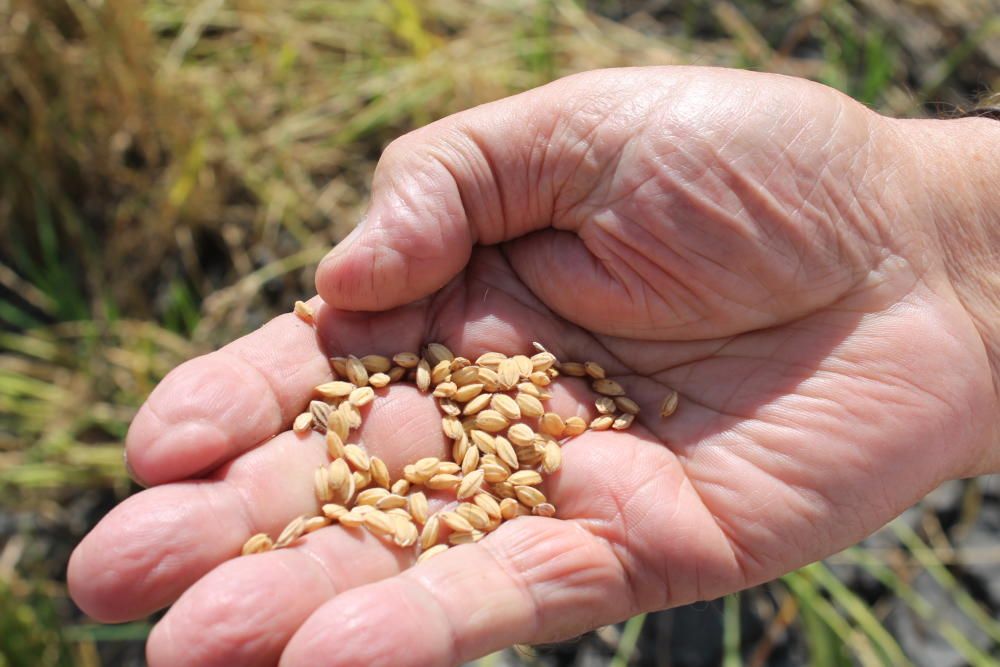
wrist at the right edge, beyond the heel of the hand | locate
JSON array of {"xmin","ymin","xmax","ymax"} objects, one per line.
[{"xmin": 902, "ymin": 118, "xmax": 1000, "ymax": 474}]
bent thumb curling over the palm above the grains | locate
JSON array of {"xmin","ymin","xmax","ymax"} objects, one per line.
[{"xmin": 316, "ymin": 73, "xmax": 592, "ymax": 311}]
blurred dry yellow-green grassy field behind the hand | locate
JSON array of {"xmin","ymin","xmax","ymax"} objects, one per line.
[{"xmin": 0, "ymin": 0, "xmax": 1000, "ymax": 667}]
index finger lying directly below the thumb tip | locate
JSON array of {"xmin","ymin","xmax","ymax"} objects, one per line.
[{"xmin": 125, "ymin": 306, "xmax": 330, "ymax": 485}]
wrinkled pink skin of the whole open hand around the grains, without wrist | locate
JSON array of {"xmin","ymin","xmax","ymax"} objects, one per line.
[{"xmin": 69, "ymin": 68, "xmax": 997, "ymax": 667}]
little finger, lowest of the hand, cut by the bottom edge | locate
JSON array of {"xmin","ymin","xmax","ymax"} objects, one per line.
[{"xmin": 281, "ymin": 517, "xmax": 633, "ymax": 667}]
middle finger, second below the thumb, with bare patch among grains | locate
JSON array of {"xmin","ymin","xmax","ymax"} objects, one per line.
[{"xmin": 68, "ymin": 387, "xmax": 445, "ymax": 622}]
